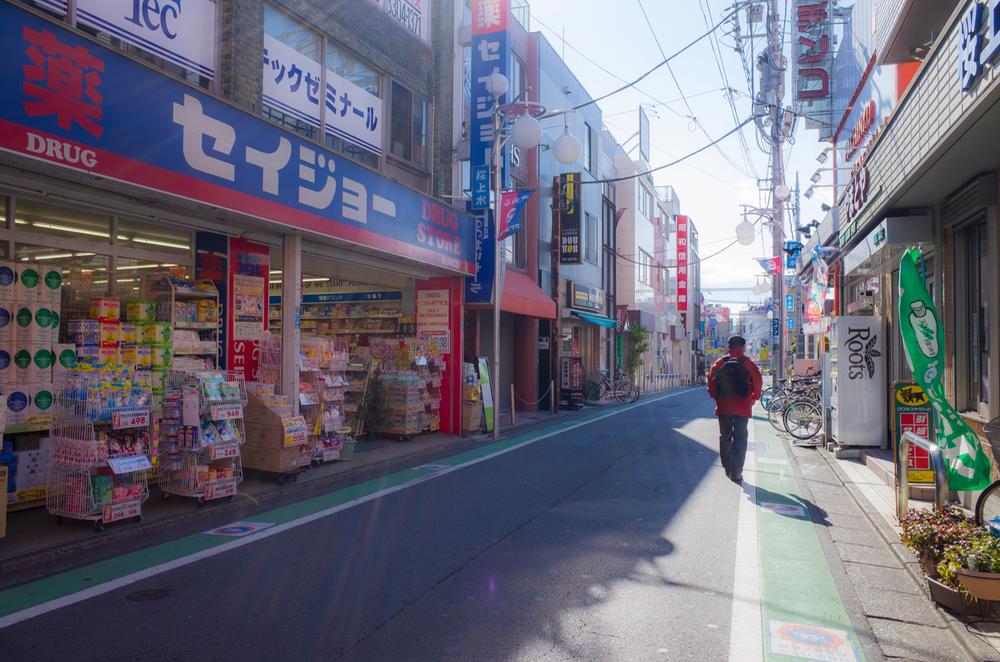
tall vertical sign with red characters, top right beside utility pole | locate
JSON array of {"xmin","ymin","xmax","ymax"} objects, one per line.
[{"xmin": 792, "ymin": 0, "xmax": 834, "ymax": 140}]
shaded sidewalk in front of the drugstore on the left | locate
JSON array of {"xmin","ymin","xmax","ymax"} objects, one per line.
[{"xmin": 0, "ymin": 393, "xmax": 648, "ymax": 588}]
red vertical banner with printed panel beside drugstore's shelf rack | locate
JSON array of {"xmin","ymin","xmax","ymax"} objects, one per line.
[{"xmin": 225, "ymin": 237, "xmax": 270, "ymax": 382}]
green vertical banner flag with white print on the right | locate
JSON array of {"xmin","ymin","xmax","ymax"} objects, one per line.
[{"xmin": 899, "ymin": 248, "xmax": 990, "ymax": 492}]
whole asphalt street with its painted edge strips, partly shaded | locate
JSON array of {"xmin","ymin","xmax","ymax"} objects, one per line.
[{"xmin": 0, "ymin": 389, "xmax": 984, "ymax": 662}]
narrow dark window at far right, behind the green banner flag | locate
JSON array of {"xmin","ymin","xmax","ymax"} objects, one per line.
[{"xmin": 956, "ymin": 221, "xmax": 992, "ymax": 415}]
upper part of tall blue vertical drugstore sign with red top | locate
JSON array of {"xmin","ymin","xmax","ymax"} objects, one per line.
[{"xmin": 469, "ymin": 0, "xmax": 510, "ymax": 172}]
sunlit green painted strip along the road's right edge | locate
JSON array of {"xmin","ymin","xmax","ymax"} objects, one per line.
[{"xmin": 752, "ymin": 422, "xmax": 865, "ymax": 662}]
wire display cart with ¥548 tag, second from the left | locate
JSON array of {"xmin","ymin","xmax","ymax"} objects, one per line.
[{"xmin": 159, "ymin": 370, "xmax": 247, "ymax": 506}]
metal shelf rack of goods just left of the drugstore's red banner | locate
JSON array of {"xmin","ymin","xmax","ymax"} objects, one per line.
[{"xmin": 140, "ymin": 274, "xmax": 219, "ymax": 372}]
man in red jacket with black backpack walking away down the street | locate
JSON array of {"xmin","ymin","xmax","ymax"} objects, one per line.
[{"xmin": 708, "ymin": 336, "xmax": 763, "ymax": 483}]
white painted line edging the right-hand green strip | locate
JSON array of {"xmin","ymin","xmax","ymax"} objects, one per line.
[{"xmin": 729, "ymin": 420, "xmax": 764, "ymax": 662}]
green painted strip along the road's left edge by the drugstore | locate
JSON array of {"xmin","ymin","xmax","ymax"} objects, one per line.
[{"xmin": 0, "ymin": 389, "xmax": 695, "ymax": 628}]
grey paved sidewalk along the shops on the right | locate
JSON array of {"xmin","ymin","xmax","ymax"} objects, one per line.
[{"xmin": 756, "ymin": 420, "xmax": 1000, "ymax": 662}]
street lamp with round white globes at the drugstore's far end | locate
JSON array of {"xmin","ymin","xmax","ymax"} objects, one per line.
[{"xmin": 486, "ymin": 71, "xmax": 581, "ymax": 439}]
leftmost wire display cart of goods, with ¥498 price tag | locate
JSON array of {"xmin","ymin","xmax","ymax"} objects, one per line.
[{"xmin": 46, "ymin": 368, "xmax": 153, "ymax": 531}]
